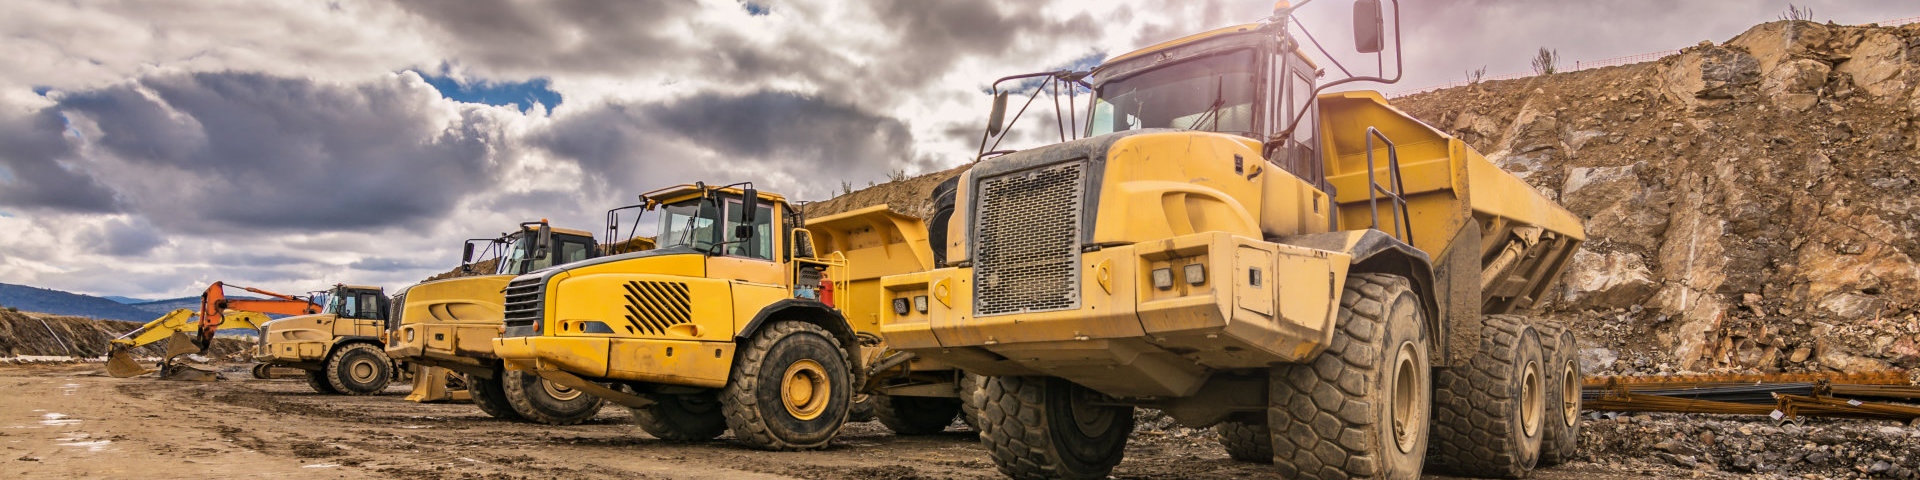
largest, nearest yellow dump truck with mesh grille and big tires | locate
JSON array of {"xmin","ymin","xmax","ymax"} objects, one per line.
[{"xmin": 879, "ymin": 0, "xmax": 1584, "ymax": 478}]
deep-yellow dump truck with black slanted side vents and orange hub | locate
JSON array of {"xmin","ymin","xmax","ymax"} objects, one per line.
[{"xmin": 493, "ymin": 184, "xmax": 958, "ymax": 449}]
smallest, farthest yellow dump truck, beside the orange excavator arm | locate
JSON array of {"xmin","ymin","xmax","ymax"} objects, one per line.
[{"xmin": 255, "ymin": 284, "xmax": 396, "ymax": 396}]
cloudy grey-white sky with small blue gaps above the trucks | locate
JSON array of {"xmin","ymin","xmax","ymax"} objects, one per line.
[{"xmin": 0, "ymin": 0, "xmax": 1920, "ymax": 298}]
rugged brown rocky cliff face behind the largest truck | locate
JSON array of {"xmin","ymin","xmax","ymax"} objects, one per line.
[{"xmin": 1394, "ymin": 21, "xmax": 1920, "ymax": 371}]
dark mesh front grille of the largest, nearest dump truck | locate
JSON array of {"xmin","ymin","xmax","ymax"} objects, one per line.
[{"xmin": 973, "ymin": 161, "xmax": 1087, "ymax": 317}]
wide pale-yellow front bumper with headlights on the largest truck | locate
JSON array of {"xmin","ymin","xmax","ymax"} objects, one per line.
[{"xmin": 879, "ymin": 232, "xmax": 1350, "ymax": 397}]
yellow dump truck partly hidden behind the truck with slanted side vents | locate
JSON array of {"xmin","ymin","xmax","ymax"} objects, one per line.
[{"xmin": 386, "ymin": 221, "xmax": 645, "ymax": 424}]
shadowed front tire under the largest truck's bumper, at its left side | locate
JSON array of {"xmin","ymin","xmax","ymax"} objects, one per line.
[{"xmin": 979, "ymin": 376, "xmax": 1133, "ymax": 480}]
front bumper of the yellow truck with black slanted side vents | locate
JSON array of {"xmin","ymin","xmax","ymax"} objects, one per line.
[{"xmin": 493, "ymin": 336, "xmax": 733, "ymax": 388}]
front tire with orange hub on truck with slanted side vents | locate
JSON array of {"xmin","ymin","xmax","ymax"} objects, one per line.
[{"xmin": 720, "ymin": 321, "xmax": 848, "ymax": 449}]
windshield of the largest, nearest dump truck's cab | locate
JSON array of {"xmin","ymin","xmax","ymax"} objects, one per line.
[{"xmin": 1087, "ymin": 50, "xmax": 1258, "ymax": 136}]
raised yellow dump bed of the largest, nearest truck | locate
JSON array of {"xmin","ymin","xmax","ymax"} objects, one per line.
[{"xmin": 1319, "ymin": 92, "xmax": 1586, "ymax": 313}]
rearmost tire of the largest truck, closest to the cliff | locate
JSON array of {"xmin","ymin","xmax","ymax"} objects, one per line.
[{"xmin": 1534, "ymin": 323, "xmax": 1586, "ymax": 467}]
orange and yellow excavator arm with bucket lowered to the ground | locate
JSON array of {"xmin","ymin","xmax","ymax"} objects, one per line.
[{"xmin": 108, "ymin": 282, "xmax": 321, "ymax": 382}]
